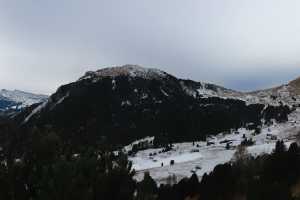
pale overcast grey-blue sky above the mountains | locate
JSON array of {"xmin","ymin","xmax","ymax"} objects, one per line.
[{"xmin": 0, "ymin": 0, "xmax": 300, "ymax": 93}]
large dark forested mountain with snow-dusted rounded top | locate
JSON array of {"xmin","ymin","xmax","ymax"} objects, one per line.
[{"xmin": 16, "ymin": 65, "xmax": 291, "ymax": 146}]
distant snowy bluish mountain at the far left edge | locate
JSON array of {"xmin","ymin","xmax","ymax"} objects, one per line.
[{"xmin": 0, "ymin": 89, "xmax": 48, "ymax": 114}]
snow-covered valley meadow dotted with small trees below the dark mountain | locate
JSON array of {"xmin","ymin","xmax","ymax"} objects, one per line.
[{"xmin": 129, "ymin": 110, "xmax": 300, "ymax": 183}]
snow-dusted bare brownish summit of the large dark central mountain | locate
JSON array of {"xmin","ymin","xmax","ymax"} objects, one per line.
[{"xmin": 79, "ymin": 65, "xmax": 167, "ymax": 80}]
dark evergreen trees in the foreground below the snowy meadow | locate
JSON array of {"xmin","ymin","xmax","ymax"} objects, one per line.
[{"xmin": 0, "ymin": 119, "xmax": 300, "ymax": 200}]
